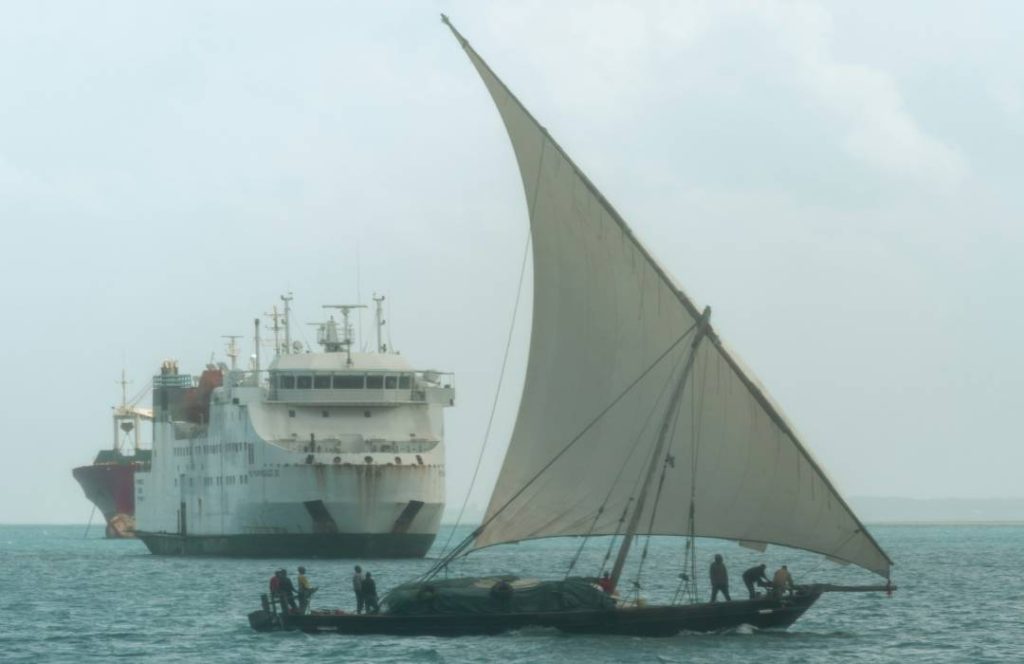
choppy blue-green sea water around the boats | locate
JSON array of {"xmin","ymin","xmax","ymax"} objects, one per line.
[{"xmin": 0, "ymin": 526, "xmax": 1024, "ymax": 664}]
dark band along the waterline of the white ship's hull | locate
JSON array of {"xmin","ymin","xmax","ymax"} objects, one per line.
[{"xmin": 136, "ymin": 532, "xmax": 435, "ymax": 558}]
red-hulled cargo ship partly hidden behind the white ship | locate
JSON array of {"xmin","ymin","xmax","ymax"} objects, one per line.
[{"xmin": 72, "ymin": 372, "xmax": 153, "ymax": 539}]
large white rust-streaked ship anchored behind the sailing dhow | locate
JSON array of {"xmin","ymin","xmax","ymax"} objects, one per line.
[{"xmin": 135, "ymin": 298, "xmax": 455, "ymax": 557}]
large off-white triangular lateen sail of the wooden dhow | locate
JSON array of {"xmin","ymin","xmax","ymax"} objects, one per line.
[{"xmin": 453, "ymin": 18, "xmax": 891, "ymax": 577}]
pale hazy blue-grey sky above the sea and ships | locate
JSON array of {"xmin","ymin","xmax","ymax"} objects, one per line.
[{"xmin": 0, "ymin": 1, "xmax": 1024, "ymax": 523}]
